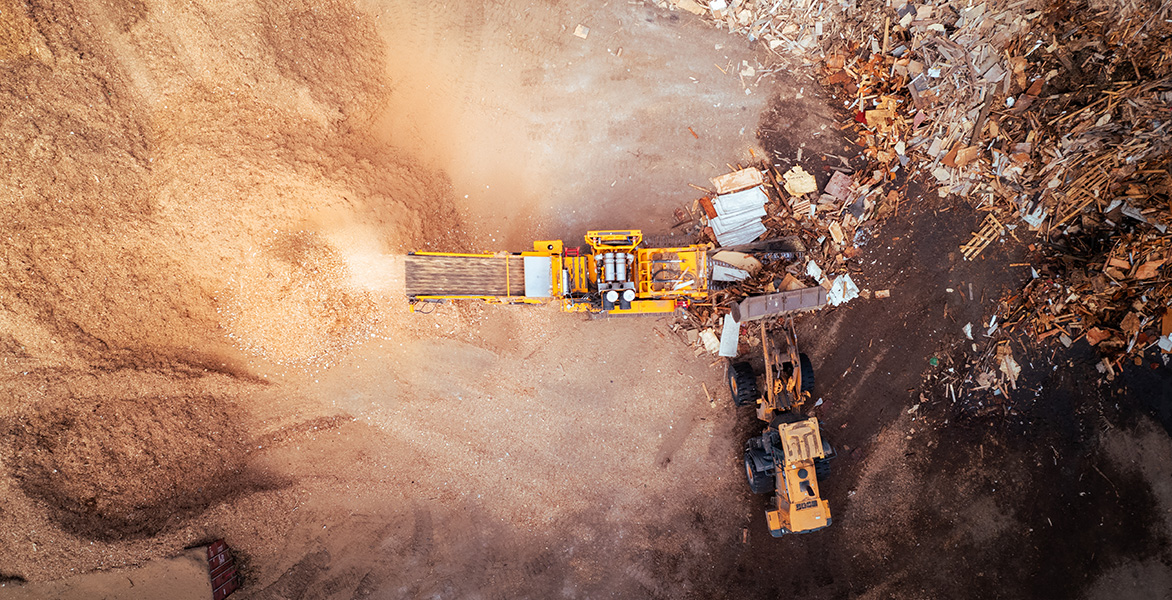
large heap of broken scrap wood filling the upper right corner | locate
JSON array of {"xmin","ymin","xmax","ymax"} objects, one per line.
[{"xmin": 663, "ymin": 0, "xmax": 1172, "ymax": 364}]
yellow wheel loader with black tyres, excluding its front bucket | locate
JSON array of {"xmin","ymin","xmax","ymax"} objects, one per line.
[{"xmin": 728, "ymin": 320, "xmax": 834, "ymax": 537}]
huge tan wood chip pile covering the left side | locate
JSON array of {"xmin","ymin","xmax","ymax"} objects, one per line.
[{"xmin": 0, "ymin": 0, "xmax": 461, "ymax": 579}]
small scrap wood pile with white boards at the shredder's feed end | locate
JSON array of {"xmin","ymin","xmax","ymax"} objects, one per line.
[{"xmin": 686, "ymin": 164, "xmax": 890, "ymax": 353}]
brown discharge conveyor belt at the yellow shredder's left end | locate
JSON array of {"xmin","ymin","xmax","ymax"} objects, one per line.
[{"xmin": 407, "ymin": 254, "xmax": 525, "ymax": 296}]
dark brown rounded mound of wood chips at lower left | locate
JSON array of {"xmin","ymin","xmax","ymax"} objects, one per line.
[{"xmin": 9, "ymin": 396, "xmax": 263, "ymax": 540}]
